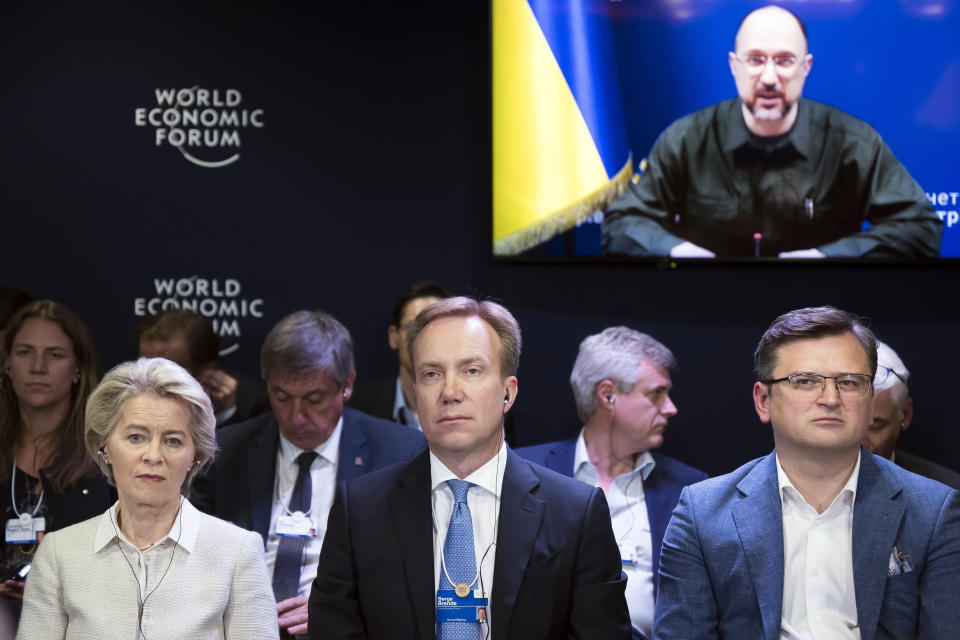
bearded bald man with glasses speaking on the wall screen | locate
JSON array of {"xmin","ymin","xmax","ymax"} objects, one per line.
[{"xmin": 603, "ymin": 6, "xmax": 942, "ymax": 258}]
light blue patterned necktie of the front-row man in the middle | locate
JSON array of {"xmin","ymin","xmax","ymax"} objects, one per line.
[{"xmin": 437, "ymin": 480, "xmax": 480, "ymax": 640}]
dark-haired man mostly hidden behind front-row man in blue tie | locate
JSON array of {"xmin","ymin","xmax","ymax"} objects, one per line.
[{"xmin": 349, "ymin": 280, "xmax": 450, "ymax": 431}]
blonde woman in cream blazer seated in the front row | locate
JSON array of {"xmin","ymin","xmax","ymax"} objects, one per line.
[{"xmin": 17, "ymin": 358, "xmax": 278, "ymax": 640}]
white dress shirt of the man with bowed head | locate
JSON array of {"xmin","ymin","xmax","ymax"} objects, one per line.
[{"xmin": 266, "ymin": 417, "xmax": 343, "ymax": 597}]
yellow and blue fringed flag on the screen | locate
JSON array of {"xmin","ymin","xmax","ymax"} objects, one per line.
[{"xmin": 493, "ymin": 0, "xmax": 631, "ymax": 255}]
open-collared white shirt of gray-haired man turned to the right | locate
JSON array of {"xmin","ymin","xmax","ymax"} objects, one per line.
[{"xmin": 573, "ymin": 429, "xmax": 656, "ymax": 638}]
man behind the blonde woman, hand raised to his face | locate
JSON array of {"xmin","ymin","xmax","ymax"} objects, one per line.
[{"xmin": 137, "ymin": 309, "xmax": 270, "ymax": 427}]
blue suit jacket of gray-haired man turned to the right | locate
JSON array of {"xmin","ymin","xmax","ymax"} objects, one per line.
[{"xmin": 517, "ymin": 438, "xmax": 707, "ymax": 594}]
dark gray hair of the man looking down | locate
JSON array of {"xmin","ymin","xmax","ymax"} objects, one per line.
[{"xmin": 260, "ymin": 311, "xmax": 354, "ymax": 387}]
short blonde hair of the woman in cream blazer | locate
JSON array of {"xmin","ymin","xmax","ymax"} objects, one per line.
[{"xmin": 83, "ymin": 358, "xmax": 217, "ymax": 493}]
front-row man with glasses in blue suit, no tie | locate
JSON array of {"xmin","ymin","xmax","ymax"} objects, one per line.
[{"xmin": 654, "ymin": 307, "xmax": 960, "ymax": 640}]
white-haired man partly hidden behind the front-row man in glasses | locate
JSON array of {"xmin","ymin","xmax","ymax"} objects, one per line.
[{"xmin": 863, "ymin": 340, "xmax": 960, "ymax": 489}]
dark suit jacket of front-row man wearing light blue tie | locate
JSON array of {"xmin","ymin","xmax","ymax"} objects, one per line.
[{"xmin": 309, "ymin": 451, "xmax": 630, "ymax": 640}]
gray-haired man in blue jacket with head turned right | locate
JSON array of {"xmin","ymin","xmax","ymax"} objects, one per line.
[{"xmin": 517, "ymin": 327, "xmax": 707, "ymax": 638}]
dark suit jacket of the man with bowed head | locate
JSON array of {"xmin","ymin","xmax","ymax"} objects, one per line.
[{"xmin": 190, "ymin": 409, "xmax": 427, "ymax": 543}]
